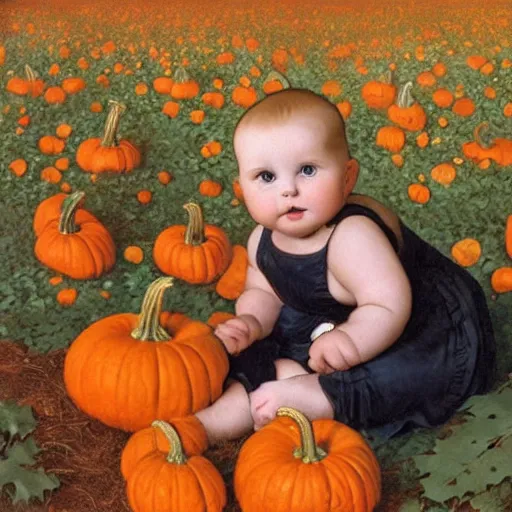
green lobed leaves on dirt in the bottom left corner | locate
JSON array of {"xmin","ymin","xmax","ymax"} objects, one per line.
[{"xmin": 0, "ymin": 401, "xmax": 60, "ymax": 504}]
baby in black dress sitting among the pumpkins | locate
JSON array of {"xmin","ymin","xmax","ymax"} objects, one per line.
[{"xmin": 196, "ymin": 89, "xmax": 495, "ymax": 443}]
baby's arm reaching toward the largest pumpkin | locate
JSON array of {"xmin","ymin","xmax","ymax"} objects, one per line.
[{"xmin": 215, "ymin": 226, "xmax": 283, "ymax": 355}]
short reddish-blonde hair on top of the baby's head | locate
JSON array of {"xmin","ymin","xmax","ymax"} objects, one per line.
[{"xmin": 233, "ymin": 88, "xmax": 350, "ymax": 158}]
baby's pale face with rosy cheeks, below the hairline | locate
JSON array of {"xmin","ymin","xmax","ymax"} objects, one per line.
[{"xmin": 234, "ymin": 117, "xmax": 350, "ymax": 238}]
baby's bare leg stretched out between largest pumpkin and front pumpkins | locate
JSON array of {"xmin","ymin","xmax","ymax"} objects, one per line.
[{"xmin": 196, "ymin": 381, "xmax": 253, "ymax": 444}]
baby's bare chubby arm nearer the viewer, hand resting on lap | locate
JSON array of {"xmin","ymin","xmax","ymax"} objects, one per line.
[{"xmin": 308, "ymin": 216, "xmax": 412, "ymax": 374}]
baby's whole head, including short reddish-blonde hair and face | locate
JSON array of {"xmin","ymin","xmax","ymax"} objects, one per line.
[{"xmin": 233, "ymin": 89, "xmax": 357, "ymax": 237}]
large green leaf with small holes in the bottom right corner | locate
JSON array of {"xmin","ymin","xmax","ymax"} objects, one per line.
[{"xmin": 413, "ymin": 382, "xmax": 512, "ymax": 503}]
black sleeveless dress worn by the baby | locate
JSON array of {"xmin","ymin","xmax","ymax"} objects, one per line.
[{"xmin": 230, "ymin": 204, "xmax": 496, "ymax": 437}]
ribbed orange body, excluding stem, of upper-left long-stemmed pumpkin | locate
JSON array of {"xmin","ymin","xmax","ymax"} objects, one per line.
[{"xmin": 76, "ymin": 137, "xmax": 140, "ymax": 173}]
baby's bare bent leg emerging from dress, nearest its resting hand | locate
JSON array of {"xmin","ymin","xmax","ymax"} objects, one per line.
[{"xmin": 249, "ymin": 359, "xmax": 334, "ymax": 430}]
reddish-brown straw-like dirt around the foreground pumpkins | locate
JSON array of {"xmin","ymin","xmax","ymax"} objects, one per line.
[{"xmin": 0, "ymin": 341, "xmax": 472, "ymax": 512}]
